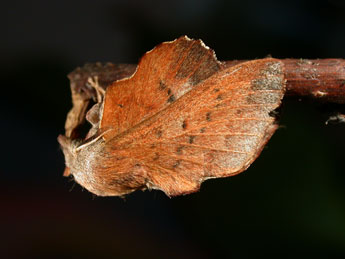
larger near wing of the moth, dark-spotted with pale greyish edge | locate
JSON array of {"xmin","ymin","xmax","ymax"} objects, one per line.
[{"xmin": 108, "ymin": 58, "xmax": 285, "ymax": 196}]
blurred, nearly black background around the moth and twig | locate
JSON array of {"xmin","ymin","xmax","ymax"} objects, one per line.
[{"xmin": 0, "ymin": 0, "xmax": 345, "ymax": 258}]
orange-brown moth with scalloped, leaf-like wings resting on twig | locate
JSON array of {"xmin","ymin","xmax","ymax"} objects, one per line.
[{"xmin": 58, "ymin": 37, "xmax": 285, "ymax": 196}]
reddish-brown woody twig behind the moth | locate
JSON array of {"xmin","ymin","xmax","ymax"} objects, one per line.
[{"xmin": 68, "ymin": 59, "xmax": 345, "ymax": 103}]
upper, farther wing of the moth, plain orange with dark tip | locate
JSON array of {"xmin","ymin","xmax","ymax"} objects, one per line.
[{"xmin": 101, "ymin": 37, "xmax": 221, "ymax": 138}]
